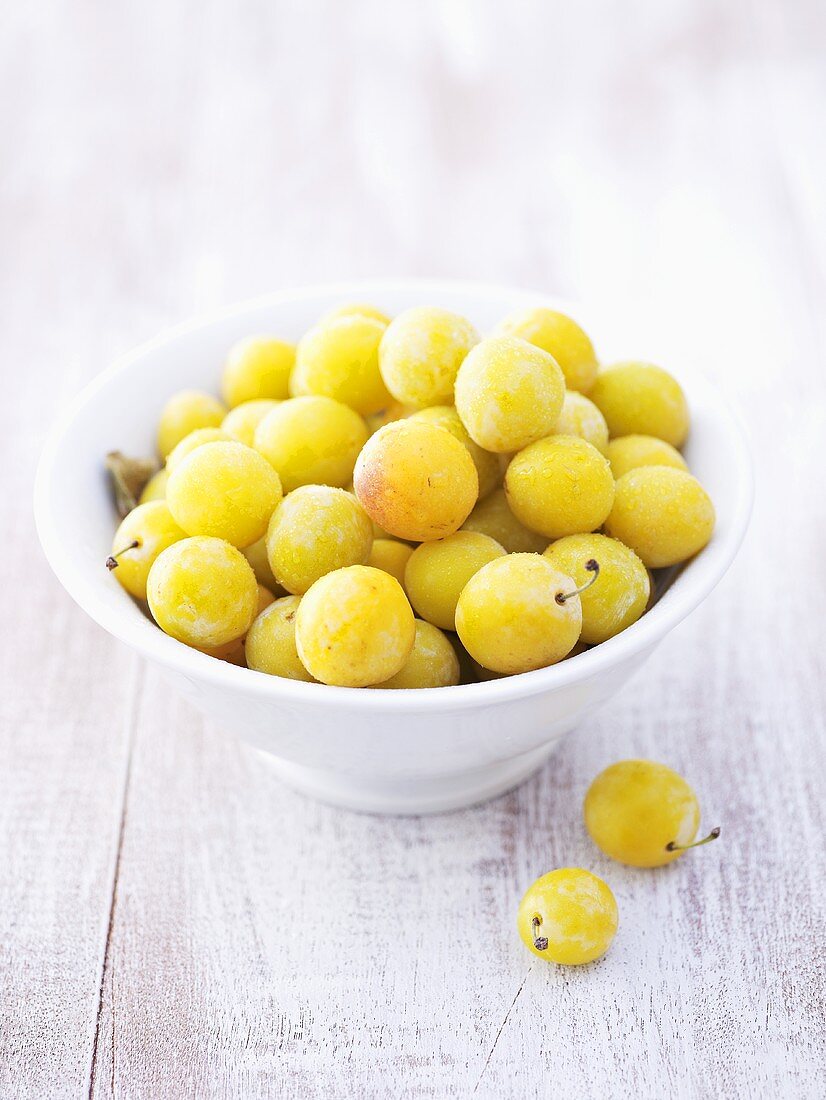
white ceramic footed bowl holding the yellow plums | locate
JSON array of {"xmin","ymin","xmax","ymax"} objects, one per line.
[{"xmin": 35, "ymin": 281, "xmax": 752, "ymax": 813}]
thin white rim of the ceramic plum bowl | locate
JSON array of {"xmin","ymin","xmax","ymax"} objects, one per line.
[{"xmin": 34, "ymin": 278, "xmax": 753, "ymax": 713}]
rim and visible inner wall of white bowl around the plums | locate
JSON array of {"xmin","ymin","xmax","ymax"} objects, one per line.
[{"xmin": 35, "ymin": 281, "xmax": 751, "ymax": 706}]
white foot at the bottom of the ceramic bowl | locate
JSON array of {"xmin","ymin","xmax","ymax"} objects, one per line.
[{"xmin": 258, "ymin": 740, "xmax": 559, "ymax": 815}]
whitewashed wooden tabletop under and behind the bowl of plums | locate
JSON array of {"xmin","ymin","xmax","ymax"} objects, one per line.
[{"xmin": 0, "ymin": 0, "xmax": 826, "ymax": 1100}]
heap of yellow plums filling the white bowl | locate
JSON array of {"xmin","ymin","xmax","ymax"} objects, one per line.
[{"xmin": 107, "ymin": 305, "xmax": 714, "ymax": 688}]
